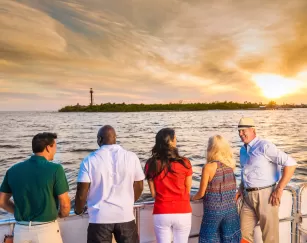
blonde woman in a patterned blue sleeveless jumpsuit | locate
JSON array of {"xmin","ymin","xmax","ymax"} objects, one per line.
[{"xmin": 192, "ymin": 135, "xmax": 241, "ymax": 243}]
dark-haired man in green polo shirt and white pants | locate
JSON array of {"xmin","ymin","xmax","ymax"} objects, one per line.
[{"xmin": 0, "ymin": 133, "xmax": 70, "ymax": 243}]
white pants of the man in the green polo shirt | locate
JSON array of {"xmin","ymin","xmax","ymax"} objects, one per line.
[{"xmin": 14, "ymin": 221, "xmax": 63, "ymax": 243}]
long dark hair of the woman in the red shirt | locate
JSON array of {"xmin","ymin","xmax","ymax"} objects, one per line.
[{"xmin": 145, "ymin": 128, "xmax": 190, "ymax": 180}]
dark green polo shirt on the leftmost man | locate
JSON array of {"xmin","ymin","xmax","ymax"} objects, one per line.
[{"xmin": 0, "ymin": 155, "xmax": 69, "ymax": 222}]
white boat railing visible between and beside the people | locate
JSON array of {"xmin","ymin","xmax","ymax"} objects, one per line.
[{"xmin": 0, "ymin": 183, "xmax": 307, "ymax": 243}]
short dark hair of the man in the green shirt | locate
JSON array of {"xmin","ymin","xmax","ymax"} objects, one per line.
[{"xmin": 32, "ymin": 132, "xmax": 58, "ymax": 153}]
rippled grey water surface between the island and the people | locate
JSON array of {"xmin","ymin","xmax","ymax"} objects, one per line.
[{"xmin": 0, "ymin": 109, "xmax": 307, "ymax": 215}]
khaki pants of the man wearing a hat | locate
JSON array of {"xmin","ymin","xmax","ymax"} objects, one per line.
[{"xmin": 240, "ymin": 187, "xmax": 279, "ymax": 243}]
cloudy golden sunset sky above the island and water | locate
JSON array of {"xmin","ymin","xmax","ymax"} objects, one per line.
[{"xmin": 0, "ymin": 0, "xmax": 307, "ymax": 110}]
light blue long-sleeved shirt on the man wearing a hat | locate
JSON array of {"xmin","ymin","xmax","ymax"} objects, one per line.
[{"xmin": 240, "ymin": 137, "xmax": 296, "ymax": 188}]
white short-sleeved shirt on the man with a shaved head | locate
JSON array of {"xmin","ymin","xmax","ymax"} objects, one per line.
[{"xmin": 78, "ymin": 144, "xmax": 145, "ymax": 224}]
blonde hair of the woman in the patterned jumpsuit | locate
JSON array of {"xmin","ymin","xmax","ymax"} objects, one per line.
[{"xmin": 207, "ymin": 135, "xmax": 236, "ymax": 169}]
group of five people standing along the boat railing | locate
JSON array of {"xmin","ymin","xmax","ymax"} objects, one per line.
[{"xmin": 0, "ymin": 117, "xmax": 296, "ymax": 243}]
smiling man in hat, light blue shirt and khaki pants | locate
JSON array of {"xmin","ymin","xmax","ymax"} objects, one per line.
[{"xmin": 237, "ymin": 117, "xmax": 296, "ymax": 243}]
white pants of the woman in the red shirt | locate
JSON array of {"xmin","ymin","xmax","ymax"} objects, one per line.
[{"xmin": 153, "ymin": 213, "xmax": 192, "ymax": 243}]
